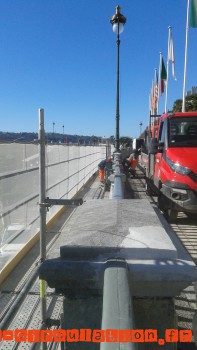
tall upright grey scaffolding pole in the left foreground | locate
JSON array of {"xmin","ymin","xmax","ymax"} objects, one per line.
[{"xmin": 38, "ymin": 108, "xmax": 47, "ymax": 350}]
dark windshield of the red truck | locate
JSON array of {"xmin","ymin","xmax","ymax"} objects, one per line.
[{"xmin": 168, "ymin": 117, "xmax": 197, "ymax": 147}]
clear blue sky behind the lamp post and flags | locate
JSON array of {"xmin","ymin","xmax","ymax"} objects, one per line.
[{"xmin": 0, "ymin": 0, "xmax": 197, "ymax": 137}]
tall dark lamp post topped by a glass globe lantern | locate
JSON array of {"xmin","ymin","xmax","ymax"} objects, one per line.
[{"xmin": 110, "ymin": 6, "xmax": 126, "ymax": 152}]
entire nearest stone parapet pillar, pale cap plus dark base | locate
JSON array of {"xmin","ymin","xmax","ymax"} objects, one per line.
[{"xmin": 39, "ymin": 199, "xmax": 197, "ymax": 350}]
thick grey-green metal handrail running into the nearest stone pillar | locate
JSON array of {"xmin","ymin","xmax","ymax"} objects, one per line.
[{"xmin": 100, "ymin": 259, "xmax": 136, "ymax": 350}]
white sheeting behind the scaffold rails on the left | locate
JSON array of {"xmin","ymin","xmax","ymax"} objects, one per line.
[{"xmin": 0, "ymin": 143, "xmax": 106, "ymax": 259}]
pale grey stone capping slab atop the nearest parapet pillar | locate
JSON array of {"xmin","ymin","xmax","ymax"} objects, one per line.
[{"xmin": 40, "ymin": 200, "xmax": 197, "ymax": 297}]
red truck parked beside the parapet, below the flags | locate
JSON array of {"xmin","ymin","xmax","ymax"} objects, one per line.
[{"xmin": 139, "ymin": 112, "xmax": 197, "ymax": 221}]
